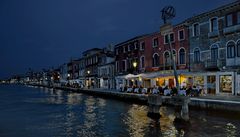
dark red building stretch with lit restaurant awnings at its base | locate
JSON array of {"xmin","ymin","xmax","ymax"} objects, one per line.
[{"xmin": 115, "ymin": 23, "xmax": 189, "ymax": 88}]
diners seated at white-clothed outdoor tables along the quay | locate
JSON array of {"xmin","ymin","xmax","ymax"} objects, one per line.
[{"xmin": 120, "ymin": 85, "xmax": 203, "ymax": 96}]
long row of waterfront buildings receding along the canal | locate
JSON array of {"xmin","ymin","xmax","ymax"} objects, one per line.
[{"xmin": 21, "ymin": 1, "xmax": 240, "ymax": 95}]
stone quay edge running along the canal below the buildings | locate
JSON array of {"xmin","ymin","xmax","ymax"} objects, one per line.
[{"xmin": 28, "ymin": 85, "xmax": 240, "ymax": 113}]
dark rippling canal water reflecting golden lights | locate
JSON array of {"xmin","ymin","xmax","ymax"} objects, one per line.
[{"xmin": 0, "ymin": 85, "xmax": 240, "ymax": 137}]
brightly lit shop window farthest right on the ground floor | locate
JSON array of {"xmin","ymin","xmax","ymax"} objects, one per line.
[{"xmin": 219, "ymin": 75, "xmax": 232, "ymax": 93}]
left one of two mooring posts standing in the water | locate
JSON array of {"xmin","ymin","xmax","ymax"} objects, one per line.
[{"xmin": 147, "ymin": 94, "xmax": 162, "ymax": 120}]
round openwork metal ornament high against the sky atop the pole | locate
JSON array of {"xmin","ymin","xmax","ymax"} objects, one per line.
[{"xmin": 161, "ymin": 6, "xmax": 176, "ymax": 24}]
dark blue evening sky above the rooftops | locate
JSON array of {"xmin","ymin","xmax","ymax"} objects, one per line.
[{"xmin": 0, "ymin": 0, "xmax": 234, "ymax": 78}]
